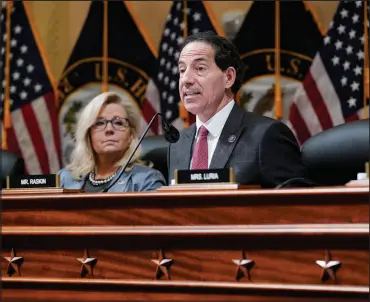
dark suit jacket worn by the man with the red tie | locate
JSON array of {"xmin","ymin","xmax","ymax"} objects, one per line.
[{"xmin": 167, "ymin": 104, "xmax": 306, "ymax": 188}]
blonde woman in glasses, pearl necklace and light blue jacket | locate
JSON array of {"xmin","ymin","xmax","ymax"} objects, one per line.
[{"xmin": 60, "ymin": 92, "xmax": 165, "ymax": 192}]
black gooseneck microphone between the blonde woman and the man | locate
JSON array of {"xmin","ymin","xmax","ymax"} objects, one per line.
[{"xmin": 103, "ymin": 112, "xmax": 180, "ymax": 192}]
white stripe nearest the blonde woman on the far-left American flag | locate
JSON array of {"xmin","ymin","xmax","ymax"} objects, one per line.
[{"xmin": 31, "ymin": 97, "xmax": 60, "ymax": 173}]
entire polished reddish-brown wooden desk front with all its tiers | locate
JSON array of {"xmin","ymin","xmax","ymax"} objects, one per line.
[{"xmin": 2, "ymin": 188, "xmax": 369, "ymax": 301}]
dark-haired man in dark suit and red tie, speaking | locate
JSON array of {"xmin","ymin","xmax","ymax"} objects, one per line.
[{"xmin": 168, "ymin": 32, "xmax": 306, "ymax": 188}]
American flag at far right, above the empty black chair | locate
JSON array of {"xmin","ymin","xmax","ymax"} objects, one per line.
[{"xmin": 288, "ymin": 1, "xmax": 369, "ymax": 144}]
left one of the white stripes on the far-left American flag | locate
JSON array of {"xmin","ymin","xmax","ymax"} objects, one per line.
[{"xmin": 12, "ymin": 109, "xmax": 42, "ymax": 174}]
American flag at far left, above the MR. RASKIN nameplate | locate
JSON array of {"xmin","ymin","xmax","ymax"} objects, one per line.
[{"xmin": 0, "ymin": 1, "xmax": 60, "ymax": 174}]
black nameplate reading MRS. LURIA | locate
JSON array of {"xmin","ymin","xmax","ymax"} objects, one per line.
[{"xmin": 175, "ymin": 168, "xmax": 235, "ymax": 184}]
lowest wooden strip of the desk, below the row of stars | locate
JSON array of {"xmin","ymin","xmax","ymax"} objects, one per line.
[{"xmin": 3, "ymin": 279, "xmax": 369, "ymax": 302}]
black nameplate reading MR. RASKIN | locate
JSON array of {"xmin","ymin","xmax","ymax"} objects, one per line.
[{"xmin": 6, "ymin": 174, "xmax": 60, "ymax": 189}]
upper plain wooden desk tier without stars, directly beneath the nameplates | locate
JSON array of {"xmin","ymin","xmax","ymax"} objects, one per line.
[{"xmin": 2, "ymin": 188, "xmax": 369, "ymax": 226}]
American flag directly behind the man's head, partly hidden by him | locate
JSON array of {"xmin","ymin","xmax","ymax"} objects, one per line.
[{"xmin": 156, "ymin": 1, "xmax": 223, "ymax": 128}]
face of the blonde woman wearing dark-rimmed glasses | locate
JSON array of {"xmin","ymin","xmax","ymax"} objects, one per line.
[{"xmin": 90, "ymin": 104, "xmax": 133, "ymax": 158}]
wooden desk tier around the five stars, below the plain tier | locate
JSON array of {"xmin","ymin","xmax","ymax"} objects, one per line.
[{"xmin": 2, "ymin": 224, "xmax": 369, "ymax": 296}]
